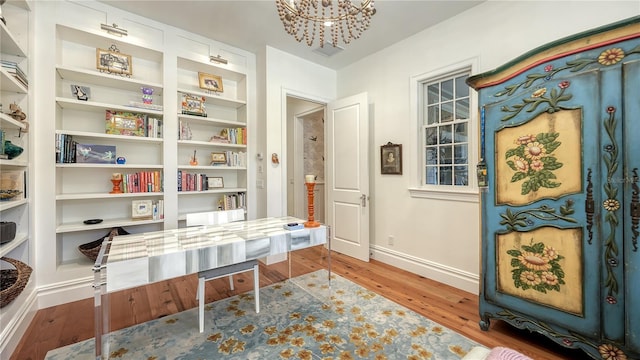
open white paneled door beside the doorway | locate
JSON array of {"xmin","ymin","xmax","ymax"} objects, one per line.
[{"xmin": 325, "ymin": 93, "xmax": 369, "ymax": 261}]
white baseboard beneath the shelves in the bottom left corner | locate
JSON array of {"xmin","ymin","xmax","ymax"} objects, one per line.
[{"xmin": 0, "ymin": 289, "xmax": 38, "ymax": 359}]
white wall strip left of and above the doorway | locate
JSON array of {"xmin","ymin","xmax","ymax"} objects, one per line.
[{"xmin": 259, "ymin": 46, "xmax": 336, "ymax": 216}]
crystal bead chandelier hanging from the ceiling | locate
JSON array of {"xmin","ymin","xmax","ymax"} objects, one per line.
[{"xmin": 276, "ymin": 0, "xmax": 376, "ymax": 47}]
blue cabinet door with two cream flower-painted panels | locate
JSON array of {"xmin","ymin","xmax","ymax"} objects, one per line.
[{"xmin": 481, "ymin": 70, "xmax": 601, "ymax": 336}]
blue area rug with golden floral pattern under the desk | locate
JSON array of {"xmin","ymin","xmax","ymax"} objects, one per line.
[{"xmin": 46, "ymin": 270, "xmax": 481, "ymax": 360}]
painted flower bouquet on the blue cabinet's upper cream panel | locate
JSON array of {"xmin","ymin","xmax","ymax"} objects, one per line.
[{"xmin": 505, "ymin": 132, "xmax": 562, "ymax": 195}]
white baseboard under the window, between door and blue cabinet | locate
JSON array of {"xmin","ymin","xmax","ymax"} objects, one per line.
[{"xmin": 370, "ymin": 246, "xmax": 480, "ymax": 295}]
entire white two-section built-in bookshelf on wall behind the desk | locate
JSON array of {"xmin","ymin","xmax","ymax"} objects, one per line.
[{"xmin": 29, "ymin": 1, "xmax": 255, "ymax": 320}]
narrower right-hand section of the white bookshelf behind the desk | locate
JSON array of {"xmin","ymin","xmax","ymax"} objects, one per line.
[{"xmin": 176, "ymin": 57, "xmax": 249, "ymax": 220}]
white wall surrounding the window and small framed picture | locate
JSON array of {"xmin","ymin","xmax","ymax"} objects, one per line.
[{"xmin": 338, "ymin": 1, "xmax": 640, "ymax": 293}]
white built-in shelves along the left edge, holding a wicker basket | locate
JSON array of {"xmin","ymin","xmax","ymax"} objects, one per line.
[{"xmin": 0, "ymin": 0, "xmax": 33, "ymax": 359}]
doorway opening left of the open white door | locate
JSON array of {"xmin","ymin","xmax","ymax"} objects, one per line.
[{"xmin": 286, "ymin": 96, "xmax": 326, "ymax": 223}]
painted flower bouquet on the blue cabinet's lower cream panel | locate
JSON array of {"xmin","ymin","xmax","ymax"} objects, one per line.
[{"xmin": 507, "ymin": 242, "xmax": 565, "ymax": 294}]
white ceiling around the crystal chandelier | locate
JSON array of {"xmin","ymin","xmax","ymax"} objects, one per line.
[{"xmin": 101, "ymin": 0, "xmax": 485, "ymax": 70}]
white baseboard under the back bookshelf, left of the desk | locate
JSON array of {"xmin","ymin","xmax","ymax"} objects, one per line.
[{"xmin": 38, "ymin": 276, "xmax": 94, "ymax": 309}]
